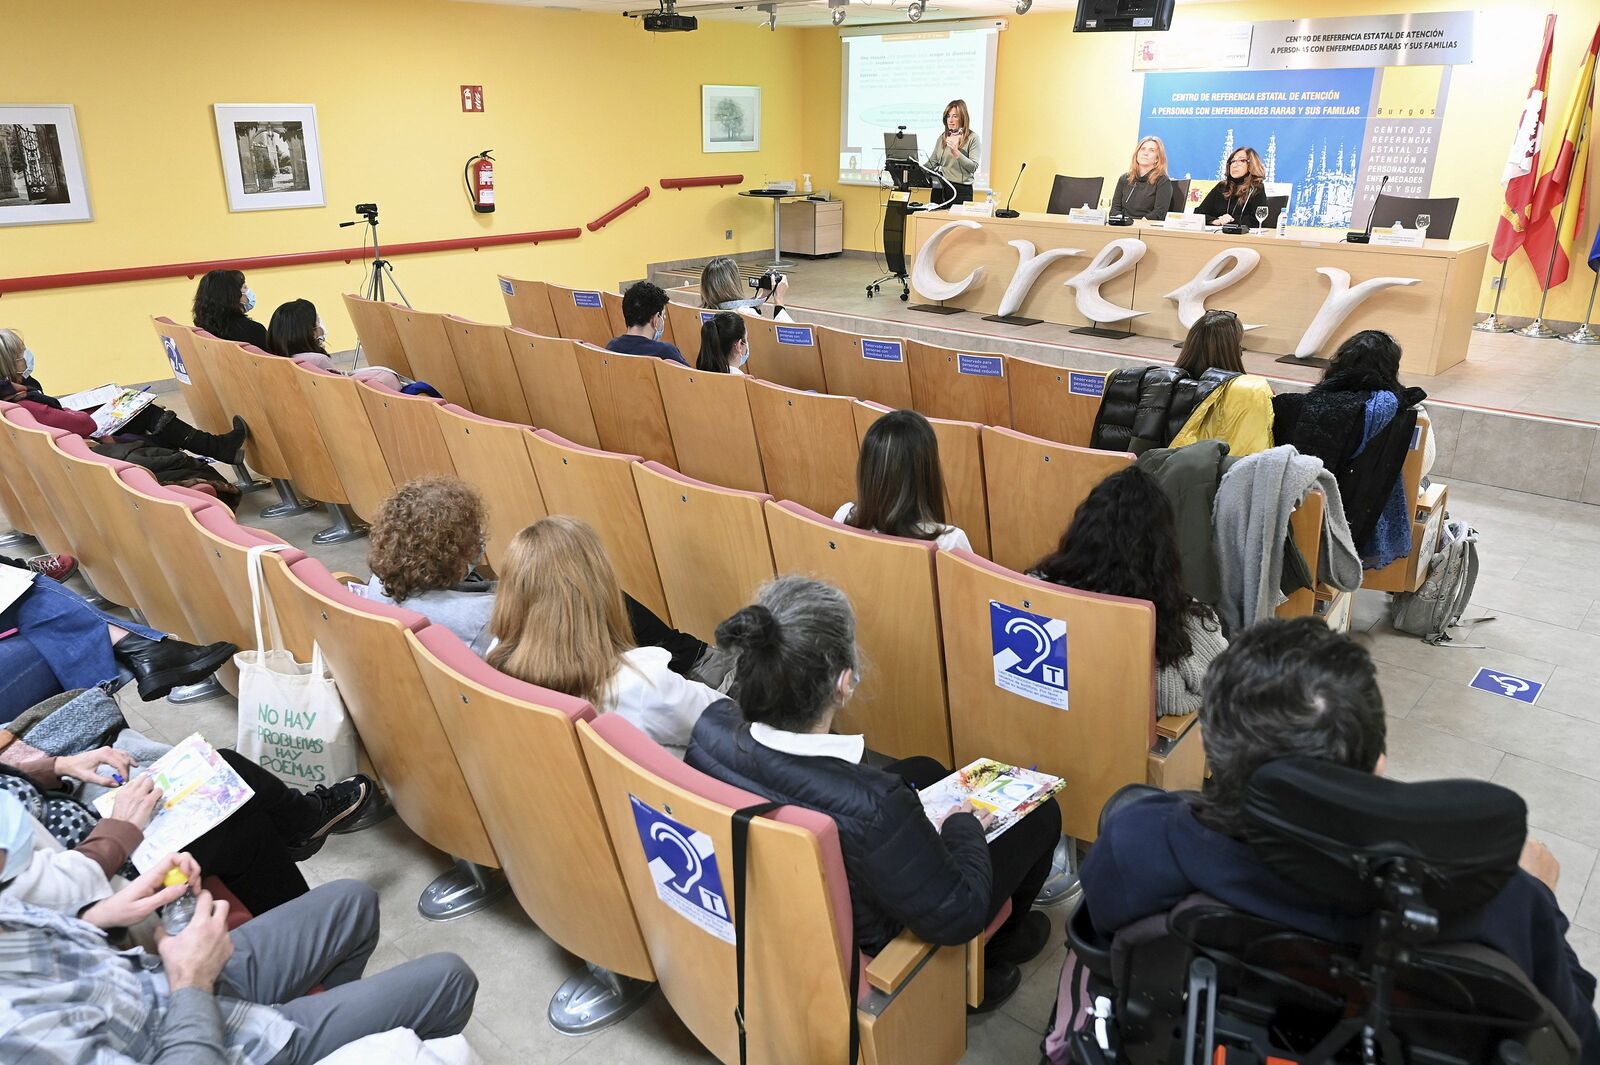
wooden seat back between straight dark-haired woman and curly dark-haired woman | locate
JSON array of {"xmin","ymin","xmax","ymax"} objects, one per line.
[{"xmin": 982, "ymin": 425, "xmax": 1133, "ymax": 572}]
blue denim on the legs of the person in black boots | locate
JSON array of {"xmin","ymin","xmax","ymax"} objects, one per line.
[{"xmin": 0, "ymin": 576, "xmax": 166, "ymax": 723}]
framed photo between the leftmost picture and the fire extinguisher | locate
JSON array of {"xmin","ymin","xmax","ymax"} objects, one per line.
[{"xmin": 213, "ymin": 104, "xmax": 323, "ymax": 211}]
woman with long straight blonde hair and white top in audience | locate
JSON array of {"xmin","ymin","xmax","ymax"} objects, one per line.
[{"xmin": 488, "ymin": 517, "xmax": 722, "ymax": 758}]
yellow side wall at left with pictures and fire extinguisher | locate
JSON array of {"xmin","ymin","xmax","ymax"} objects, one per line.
[{"xmin": 0, "ymin": 0, "xmax": 805, "ymax": 393}]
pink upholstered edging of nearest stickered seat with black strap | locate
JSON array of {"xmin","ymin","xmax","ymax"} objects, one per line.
[{"xmin": 594, "ymin": 713, "xmax": 866, "ymax": 998}]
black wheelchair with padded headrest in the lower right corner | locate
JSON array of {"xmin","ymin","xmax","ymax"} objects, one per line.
[{"xmin": 1067, "ymin": 758, "xmax": 1579, "ymax": 1065}]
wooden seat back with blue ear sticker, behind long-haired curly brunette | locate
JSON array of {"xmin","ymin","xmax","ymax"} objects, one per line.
[{"xmin": 938, "ymin": 552, "xmax": 1155, "ymax": 840}]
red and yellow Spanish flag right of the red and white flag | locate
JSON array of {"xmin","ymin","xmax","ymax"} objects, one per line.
[{"xmin": 1523, "ymin": 26, "xmax": 1600, "ymax": 289}]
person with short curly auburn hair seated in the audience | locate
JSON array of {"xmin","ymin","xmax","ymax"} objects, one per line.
[{"xmin": 366, "ymin": 477, "xmax": 494, "ymax": 656}]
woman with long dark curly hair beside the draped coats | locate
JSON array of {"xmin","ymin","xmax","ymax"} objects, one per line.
[{"xmin": 1029, "ymin": 467, "xmax": 1227, "ymax": 716}]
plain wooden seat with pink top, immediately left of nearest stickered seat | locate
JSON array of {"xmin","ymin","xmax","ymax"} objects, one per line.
[{"xmin": 406, "ymin": 625, "xmax": 656, "ymax": 1035}]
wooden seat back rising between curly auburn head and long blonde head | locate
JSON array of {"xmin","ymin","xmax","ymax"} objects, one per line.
[{"xmin": 434, "ymin": 403, "xmax": 547, "ymax": 569}]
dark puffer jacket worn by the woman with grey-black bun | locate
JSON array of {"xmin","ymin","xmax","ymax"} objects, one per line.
[{"xmin": 688, "ymin": 699, "xmax": 994, "ymax": 955}]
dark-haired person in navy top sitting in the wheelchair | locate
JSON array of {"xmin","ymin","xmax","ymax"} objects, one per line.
[{"xmin": 1082, "ymin": 617, "xmax": 1600, "ymax": 1065}]
